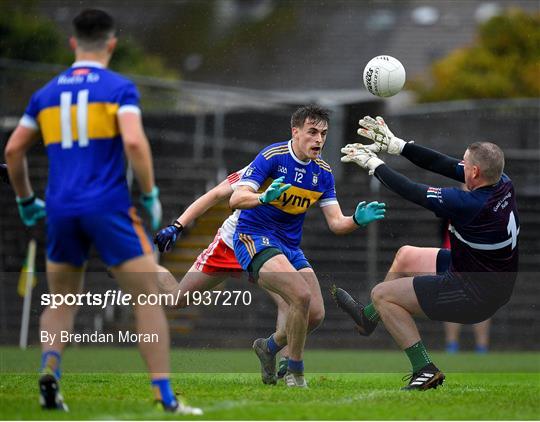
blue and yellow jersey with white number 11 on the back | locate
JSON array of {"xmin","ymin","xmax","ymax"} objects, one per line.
[{"xmin": 20, "ymin": 61, "xmax": 140, "ymax": 215}]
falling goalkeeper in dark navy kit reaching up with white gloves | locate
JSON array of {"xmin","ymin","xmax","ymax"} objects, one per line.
[{"xmin": 334, "ymin": 116, "xmax": 519, "ymax": 390}]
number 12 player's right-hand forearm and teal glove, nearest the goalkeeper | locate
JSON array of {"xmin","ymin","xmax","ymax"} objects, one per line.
[{"xmin": 322, "ymin": 201, "xmax": 386, "ymax": 235}]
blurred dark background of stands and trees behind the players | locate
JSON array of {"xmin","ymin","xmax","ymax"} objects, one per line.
[{"xmin": 0, "ymin": 0, "xmax": 540, "ymax": 350}]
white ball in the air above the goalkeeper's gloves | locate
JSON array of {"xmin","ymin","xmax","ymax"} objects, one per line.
[{"xmin": 364, "ymin": 56, "xmax": 405, "ymax": 97}]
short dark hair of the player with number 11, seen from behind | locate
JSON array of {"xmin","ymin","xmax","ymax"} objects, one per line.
[{"xmin": 73, "ymin": 9, "xmax": 115, "ymax": 50}]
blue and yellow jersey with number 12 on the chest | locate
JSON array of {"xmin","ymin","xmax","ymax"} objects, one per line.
[{"xmin": 237, "ymin": 141, "xmax": 337, "ymax": 248}]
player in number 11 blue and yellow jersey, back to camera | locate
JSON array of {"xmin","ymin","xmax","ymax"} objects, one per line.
[{"xmin": 5, "ymin": 10, "xmax": 201, "ymax": 414}]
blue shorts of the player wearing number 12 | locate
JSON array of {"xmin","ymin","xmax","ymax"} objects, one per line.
[{"xmin": 234, "ymin": 232, "xmax": 311, "ymax": 271}]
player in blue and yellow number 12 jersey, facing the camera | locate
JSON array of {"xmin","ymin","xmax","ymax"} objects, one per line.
[{"xmin": 230, "ymin": 105, "xmax": 384, "ymax": 387}]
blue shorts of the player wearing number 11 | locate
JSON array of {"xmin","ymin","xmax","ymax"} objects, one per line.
[{"xmin": 47, "ymin": 207, "xmax": 153, "ymax": 267}]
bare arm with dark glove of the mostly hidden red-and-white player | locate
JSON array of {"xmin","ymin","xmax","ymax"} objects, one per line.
[{"xmin": 154, "ymin": 176, "xmax": 233, "ymax": 252}]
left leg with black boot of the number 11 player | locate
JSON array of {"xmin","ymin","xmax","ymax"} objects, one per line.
[{"xmin": 39, "ymin": 261, "xmax": 84, "ymax": 410}]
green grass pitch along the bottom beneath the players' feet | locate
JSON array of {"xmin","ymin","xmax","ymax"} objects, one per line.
[{"xmin": 0, "ymin": 348, "xmax": 540, "ymax": 420}]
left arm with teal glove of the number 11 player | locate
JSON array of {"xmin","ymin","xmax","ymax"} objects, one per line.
[{"xmin": 4, "ymin": 125, "xmax": 46, "ymax": 227}]
